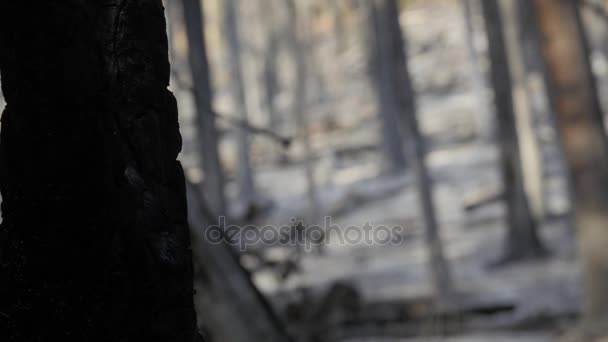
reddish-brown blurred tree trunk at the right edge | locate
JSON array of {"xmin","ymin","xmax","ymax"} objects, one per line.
[{"xmin": 534, "ymin": 0, "xmax": 608, "ymax": 335}]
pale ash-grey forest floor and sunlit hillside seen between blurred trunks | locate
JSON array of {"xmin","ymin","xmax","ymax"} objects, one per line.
[{"xmin": 176, "ymin": 0, "xmax": 581, "ymax": 342}]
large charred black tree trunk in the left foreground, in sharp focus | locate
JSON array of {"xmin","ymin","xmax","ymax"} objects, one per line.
[{"xmin": 0, "ymin": 0, "xmax": 199, "ymax": 342}]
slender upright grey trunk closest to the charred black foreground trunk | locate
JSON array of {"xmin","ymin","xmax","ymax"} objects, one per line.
[{"xmin": 182, "ymin": 0, "xmax": 226, "ymax": 216}]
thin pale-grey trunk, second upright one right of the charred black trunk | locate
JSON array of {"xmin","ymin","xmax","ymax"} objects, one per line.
[{"xmin": 224, "ymin": 0, "xmax": 256, "ymax": 208}]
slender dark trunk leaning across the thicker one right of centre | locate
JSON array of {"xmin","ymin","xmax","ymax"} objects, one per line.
[{"xmin": 372, "ymin": 0, "xmax": 456, "ymax": 309}]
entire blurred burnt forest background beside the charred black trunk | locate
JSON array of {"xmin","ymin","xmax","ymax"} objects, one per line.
[{"xmin": 158, "ymin": 0, "xmax": 608, "ymax": 341}]
